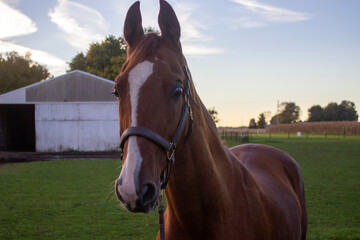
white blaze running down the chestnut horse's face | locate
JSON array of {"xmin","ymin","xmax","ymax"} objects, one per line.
[{"xmin": 119, "ymin": 61, "xmax": 154, "ymax": 208}]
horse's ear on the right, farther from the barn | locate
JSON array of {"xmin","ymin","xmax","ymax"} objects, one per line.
[{"xmin": 158, "ymin": 0, "xmax": 181, "ymax": 49}]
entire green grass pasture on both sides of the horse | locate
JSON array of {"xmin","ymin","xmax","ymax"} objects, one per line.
[{"xmin": 0, "ymin": 134, "xmax": 360, "ymax": 240}]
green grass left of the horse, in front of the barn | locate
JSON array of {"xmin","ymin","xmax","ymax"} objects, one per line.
[{"xmin": 0, "ymin": 160, "xmax": 158, "ymax": 239}]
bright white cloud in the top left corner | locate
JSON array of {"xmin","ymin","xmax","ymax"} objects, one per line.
[{"xmin": 0, "ymin": 1, "xmax": 37, "ymax": 39}]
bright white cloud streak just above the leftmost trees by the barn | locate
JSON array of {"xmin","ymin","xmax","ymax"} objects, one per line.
[{"xmin": 0, "ymin": 41, "xmax": 67, "ymax": 76}]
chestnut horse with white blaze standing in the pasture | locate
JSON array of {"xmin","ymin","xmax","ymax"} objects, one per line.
[{"xmin": 114, "ymin": 0, "xmax": 307, "ymax": 240}]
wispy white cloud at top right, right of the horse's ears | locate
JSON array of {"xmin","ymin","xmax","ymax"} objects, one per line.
[{"xmin": 231, "ymin": 0, "xmax": 312, "ymax": 28}]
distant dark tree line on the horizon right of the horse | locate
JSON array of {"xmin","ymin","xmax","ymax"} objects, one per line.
[{"xmin": 249, "ymin": 100, "xmax": 359, "ymax": 128}]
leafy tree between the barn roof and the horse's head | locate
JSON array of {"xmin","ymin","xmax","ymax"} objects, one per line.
[{"xmin": 68, "ymin": 35, "xmax": 127, "ymax": 79}]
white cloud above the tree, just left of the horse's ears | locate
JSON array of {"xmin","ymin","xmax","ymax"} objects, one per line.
[{"xmin": 49, "ymin": 0, "xmax": 108, "ymax": 50}]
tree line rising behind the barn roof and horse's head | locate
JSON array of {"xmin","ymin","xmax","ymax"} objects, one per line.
[{"xmin": 0, "ymin": 27, "xmax": 159, "ymax": 94}]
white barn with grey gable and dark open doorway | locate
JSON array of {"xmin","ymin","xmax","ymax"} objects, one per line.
[{"xmin": 0, "ymin": 70, "xmax": 120, "ymax": 152}]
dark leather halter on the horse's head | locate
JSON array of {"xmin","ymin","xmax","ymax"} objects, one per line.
[{"xmin": 119, "ymin": 65, "xmax": 193, "ymax": 189}]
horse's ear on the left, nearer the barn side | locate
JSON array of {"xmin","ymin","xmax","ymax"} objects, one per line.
[{"xmin": 124, "ymin": 1, "xmax": 144, "ymax": 48}]
